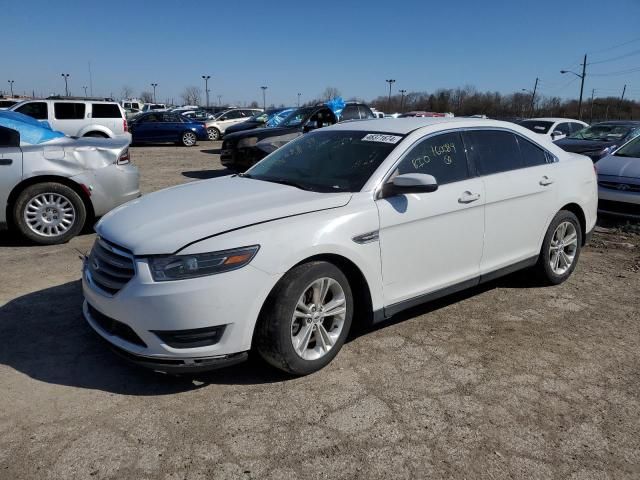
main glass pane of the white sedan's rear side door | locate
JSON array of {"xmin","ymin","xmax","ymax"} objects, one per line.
[{"xmin": 464, "ymin": 130, "xmax": 523, "ymax": 175}]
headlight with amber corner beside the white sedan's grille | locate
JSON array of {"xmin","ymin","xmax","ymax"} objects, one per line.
[{"xmin": 149, "ymin": 245, "xmax": 260, "ymax": 282}]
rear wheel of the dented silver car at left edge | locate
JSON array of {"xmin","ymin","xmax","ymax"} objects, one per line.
[{"xmin": 13, "ymin": 182, "xmax": 87, "ymax": 245}]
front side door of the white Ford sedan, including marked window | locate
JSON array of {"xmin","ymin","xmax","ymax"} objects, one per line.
[{"xmin": 376, "ymin": 132, "xmax": 484, "ymax": 314}]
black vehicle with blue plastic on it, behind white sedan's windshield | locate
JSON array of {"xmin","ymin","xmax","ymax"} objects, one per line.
[{"xmin": 220, "ymin": 102, "xmax": 375, "ymax": 171}]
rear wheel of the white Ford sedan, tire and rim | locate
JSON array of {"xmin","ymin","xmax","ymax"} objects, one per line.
[{"xmin": 536, "ymin": 210, "xmax": 582, "ymax": 285}]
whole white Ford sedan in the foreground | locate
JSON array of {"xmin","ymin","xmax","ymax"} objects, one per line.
[{"xmin": 83, "ymin": 118, "xmax": 597, "ymax": 375}]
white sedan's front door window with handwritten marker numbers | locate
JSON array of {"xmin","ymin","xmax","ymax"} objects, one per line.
[{"xmin": 398, "ymin": 132, "xmax": 469, "ymax": 185}]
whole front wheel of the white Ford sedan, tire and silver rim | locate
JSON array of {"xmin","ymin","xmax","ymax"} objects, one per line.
[{"xmin": 256, "ymin": 262, "xmax": 353, "ymax": 375}]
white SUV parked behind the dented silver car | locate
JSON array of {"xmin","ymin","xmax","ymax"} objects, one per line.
[{"xmin": 9, "ymin": 99, "xmax": 131, "ymax": 140}]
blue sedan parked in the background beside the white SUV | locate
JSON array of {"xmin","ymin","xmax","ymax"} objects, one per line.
[{"xmin": 129, "ymin": 112, "xmax": 209, "ymax": 147}]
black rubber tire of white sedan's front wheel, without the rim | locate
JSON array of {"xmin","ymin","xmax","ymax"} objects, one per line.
[{"xmin": 254, "ymin": 261, "xmax": 353, "ymax": 375}]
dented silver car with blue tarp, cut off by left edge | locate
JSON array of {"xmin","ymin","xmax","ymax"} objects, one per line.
[{"xmin": 0, "ymin": 126, "xmax": 140, "ymax": 245}]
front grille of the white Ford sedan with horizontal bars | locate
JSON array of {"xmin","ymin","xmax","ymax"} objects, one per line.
[{"xmin": 88, "ymin": 237, "xmax": 135, "ymax": 295}]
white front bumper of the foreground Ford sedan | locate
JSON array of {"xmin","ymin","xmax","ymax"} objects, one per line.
[{"xmin": 82, "ymin": 255, "xmax": 275, "ymax": 372}]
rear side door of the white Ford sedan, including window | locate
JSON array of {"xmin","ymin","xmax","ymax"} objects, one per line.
[{"xmin": 463, "ymin": 129, "xmax": 557, "ymax": 275}]
